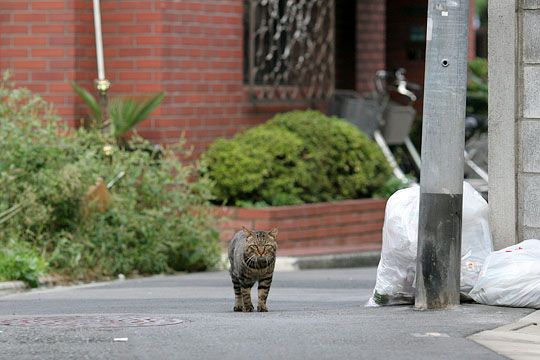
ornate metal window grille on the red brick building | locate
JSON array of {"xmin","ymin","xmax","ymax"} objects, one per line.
[{"xmin": 245, "ymin": 0, "xmax": 335, "ymax": 101}]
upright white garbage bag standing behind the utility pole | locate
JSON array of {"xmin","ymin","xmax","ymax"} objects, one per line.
[{"xmin": 367, "ymin": 182, "xmax": 493, "ymax": 306}]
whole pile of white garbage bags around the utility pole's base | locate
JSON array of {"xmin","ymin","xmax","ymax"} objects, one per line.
[{"xmin": 367, "ymin": 182, "xmax": 540, "ymax": 307}]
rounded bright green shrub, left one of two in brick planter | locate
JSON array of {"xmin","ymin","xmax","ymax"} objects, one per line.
[{"xmin": 200, "ymin": 127, "xmax": 310, "ymax": 205}]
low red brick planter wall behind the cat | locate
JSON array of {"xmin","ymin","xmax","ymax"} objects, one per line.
[{"xmin": 219, "ymin": 199, "xmax": 386, "ymax": 256}]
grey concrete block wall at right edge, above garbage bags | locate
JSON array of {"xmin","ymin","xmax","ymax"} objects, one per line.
[{"xmin": 489, "ymin": 0, "xmax": 540, "ymax": 248}]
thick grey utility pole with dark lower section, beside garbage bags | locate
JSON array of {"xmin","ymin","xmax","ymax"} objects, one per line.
[{"xmin": 415, "ymin": 0, "xmax": 469, "ymax": 310}]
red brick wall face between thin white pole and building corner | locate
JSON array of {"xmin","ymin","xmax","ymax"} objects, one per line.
[{"xmin": 97, "ymin": 0, "xmax": 163, "ymax": 145}]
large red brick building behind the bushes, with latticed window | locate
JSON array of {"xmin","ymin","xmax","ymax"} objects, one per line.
[{"xmin": 0, "ymin": 0, "xmax": 472, "ymax": 156}]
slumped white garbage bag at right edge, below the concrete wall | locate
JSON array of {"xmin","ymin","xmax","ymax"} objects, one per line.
[{"xmin": 470, "ymin": 239, "xmax": 540, "ymax": 309}]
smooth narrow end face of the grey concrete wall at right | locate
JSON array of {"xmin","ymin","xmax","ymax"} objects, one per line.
[{"xmin": 488, "ymin": 0, "xmax": 517, "ymax": 249}]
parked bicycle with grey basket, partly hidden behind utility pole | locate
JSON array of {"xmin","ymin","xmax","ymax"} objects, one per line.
[{"xmin": 329, "ymin": 68, "xmax": 489, "ymax": 193}]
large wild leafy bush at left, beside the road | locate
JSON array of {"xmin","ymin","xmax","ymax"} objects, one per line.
[{"xmin": 0, "ymin": 73, "xmax": 219, "ymax": 278}]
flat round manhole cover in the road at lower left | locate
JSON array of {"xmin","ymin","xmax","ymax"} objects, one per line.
[{"xmin": 0, "ymin": 314, "xmax": 184, "ymax": 328}]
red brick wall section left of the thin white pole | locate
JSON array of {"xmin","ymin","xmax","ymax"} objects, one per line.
[{"xmin": 0, "ymin": 0, "xmax": 95, "ymax": 124}]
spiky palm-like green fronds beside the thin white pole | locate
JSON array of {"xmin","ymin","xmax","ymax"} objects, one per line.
[{"xmin": 71, "ymin": 82, "xmax": 165, "ymax": 141}]
